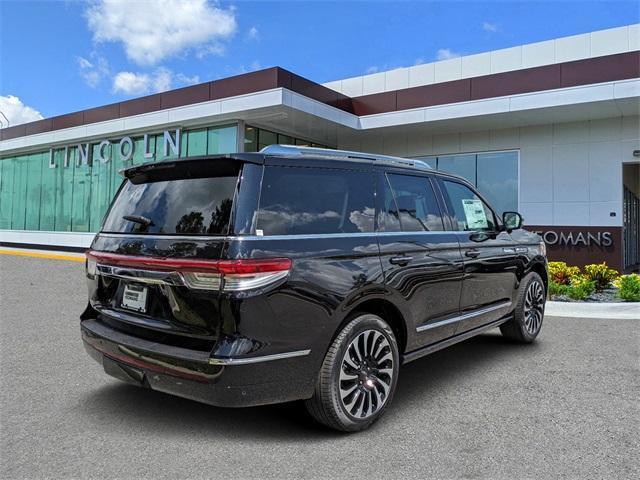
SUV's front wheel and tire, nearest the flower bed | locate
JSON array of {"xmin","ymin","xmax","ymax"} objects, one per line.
[{"xmin": 500, "ymin": 272, "xmax": 546, "ymax": 343}]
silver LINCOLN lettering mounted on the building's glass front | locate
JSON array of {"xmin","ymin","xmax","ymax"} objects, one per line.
[{"xmin": 49, "ymin": 128, "xmax": 180, "ymax": 168}]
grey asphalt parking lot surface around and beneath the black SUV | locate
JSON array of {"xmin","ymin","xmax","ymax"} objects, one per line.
[{"xmin": 0, "ymin": 255, "xmax": 640, "ymax": 479}]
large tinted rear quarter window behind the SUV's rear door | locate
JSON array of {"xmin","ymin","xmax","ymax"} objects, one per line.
[{"xmin": 256, "ymin": 166, "xmax": 374, "ymax": 235}]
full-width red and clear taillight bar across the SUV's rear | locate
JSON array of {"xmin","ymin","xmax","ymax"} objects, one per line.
[{"xmin": 86, "ymin": 251, "xmax": 291, "ymax": 292}]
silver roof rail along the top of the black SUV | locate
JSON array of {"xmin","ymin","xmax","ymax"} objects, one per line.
[{"xmin": 260, "ymin": 145, "xmax": 431, "ymax": 169}]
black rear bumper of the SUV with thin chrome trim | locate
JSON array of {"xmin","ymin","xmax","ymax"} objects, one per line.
[{"xmin": 81, "ymin": 319, "xmax": 317, "ymax": 407}]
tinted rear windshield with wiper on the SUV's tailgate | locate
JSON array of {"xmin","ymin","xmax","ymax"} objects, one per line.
[{"xmin": 102, "ymin": 173, "xmax": 238, "ymax": 235}]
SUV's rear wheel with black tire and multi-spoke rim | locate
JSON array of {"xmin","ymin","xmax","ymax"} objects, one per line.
[{"xmin": 305, "ymin": 314, "xmax": 400, "ymax": 432}]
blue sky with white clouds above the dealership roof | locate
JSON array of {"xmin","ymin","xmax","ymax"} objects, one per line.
[{"xmin": 0, "ymin": 0, "xmax": 640, "ymax": 124}]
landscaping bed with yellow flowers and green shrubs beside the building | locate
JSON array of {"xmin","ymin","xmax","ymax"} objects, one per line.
[{"xmin": 549, "ymin": 262, "xmax": 640, "ymax": 303}]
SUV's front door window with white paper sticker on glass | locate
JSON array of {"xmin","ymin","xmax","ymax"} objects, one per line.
[{"xmin": 442, "ymin": 180, "xmax": 496, "ymax": 231}]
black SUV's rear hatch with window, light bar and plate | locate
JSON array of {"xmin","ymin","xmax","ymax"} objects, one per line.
[{"xmin": 87, "ymin": 157, "xmax": 260, "ymax": 350}]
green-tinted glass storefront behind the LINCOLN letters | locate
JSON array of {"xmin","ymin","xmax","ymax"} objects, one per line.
[{"xmin": 0, "ymin": 124, "xmax": 238, "ymax": 232}]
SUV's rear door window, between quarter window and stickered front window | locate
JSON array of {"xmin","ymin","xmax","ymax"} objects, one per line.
[{"xmin": 387, "ymin": 174, "xmax": 444, "ymax": 232}]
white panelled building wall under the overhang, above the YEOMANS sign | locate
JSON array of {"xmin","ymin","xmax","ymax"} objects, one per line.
[{"xmin": 338, "ymin": 116, "xmax": 640, "ymax": 226}]
